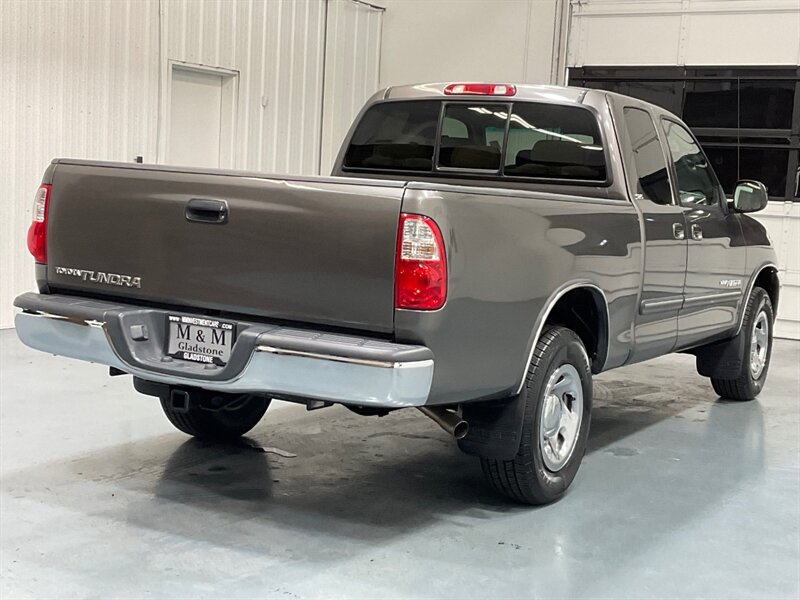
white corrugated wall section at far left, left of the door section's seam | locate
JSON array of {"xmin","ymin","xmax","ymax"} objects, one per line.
[{"xmin": 0, "ymin": 0, "xmax": 158, "ymax": 327}]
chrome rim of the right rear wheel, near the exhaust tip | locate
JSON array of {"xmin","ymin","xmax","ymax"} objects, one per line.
[{"xmin": 539, "ymin": 365, "xmax": 583, "ymax": 471}]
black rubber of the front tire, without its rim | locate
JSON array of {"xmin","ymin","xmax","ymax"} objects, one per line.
[{"xmin": 711, "ymin": 287, "xmax": 775, "ymax": 400}]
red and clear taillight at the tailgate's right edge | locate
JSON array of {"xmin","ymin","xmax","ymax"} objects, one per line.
[{"xmin": 394, "ymin": 214, "xmax": 447, "ymax": 310}]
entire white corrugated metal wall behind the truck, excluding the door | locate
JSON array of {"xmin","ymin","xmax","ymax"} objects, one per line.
[{"xmin": 0, "ymin": 0, "xmax": 379, "ymax": 327}]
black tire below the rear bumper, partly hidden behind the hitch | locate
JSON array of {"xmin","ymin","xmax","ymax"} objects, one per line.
[{"xmin": 161, "ymin": 394, "xmax": 270, "ymax": 441}]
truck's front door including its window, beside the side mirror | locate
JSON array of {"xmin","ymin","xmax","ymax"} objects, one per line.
[{"xmin": 662, "ymin": 119, "xmax": 746, "ymax": 348}]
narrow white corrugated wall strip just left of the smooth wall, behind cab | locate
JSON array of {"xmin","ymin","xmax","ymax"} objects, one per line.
[{"xmin": 320, "ymin": 0, "xmax": 383, "ymax": 174}]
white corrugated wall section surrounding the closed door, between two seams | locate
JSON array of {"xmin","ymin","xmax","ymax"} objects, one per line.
[{"xmin": 159, "ymin": 0, "xmax": 325, "ymax": 174}]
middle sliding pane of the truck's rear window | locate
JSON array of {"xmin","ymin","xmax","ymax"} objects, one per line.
[{"xmin": 438, "ymin": 103, "xmax": 508, "ymax": 171}]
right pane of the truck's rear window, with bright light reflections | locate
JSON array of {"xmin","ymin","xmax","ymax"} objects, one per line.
[{"xmin": 504, "ymin": 103, "xmax": 606, "ymax": 181}]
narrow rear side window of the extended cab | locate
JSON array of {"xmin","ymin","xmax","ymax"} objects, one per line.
[{"xmin": 622, "ymin": 108, "xmax": 672, "ymax": 204}]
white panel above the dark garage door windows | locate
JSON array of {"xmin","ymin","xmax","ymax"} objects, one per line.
[{"xmin": 568, "ymin": 0, "xmax": 800, "ymax": 67}]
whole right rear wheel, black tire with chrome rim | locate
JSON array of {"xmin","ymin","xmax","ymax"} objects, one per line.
[{"xmin": 481, "ymin": 327, "xmax": 592, "ymax": 504}]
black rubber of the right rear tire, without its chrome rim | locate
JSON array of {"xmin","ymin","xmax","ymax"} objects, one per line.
[{"xmin": 481, "ymin": 327, "xmax": 592, "ymax": 504}]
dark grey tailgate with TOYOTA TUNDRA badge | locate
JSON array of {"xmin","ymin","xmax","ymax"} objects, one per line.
[{"xmin": 47, "ymin": 161, "xmax": 403, "ymax": 332}]
